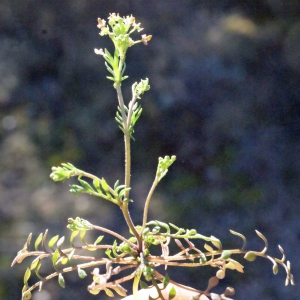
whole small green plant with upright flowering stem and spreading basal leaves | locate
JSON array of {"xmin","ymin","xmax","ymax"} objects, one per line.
[{"xmin": 12, "ymin": 13, "xmax": 294, "ymax": 300}]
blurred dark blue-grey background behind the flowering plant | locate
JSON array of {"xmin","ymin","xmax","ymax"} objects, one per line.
[{"xmin": 0, "ymin": 0, "xmax": 300, "ymax": 300}]
